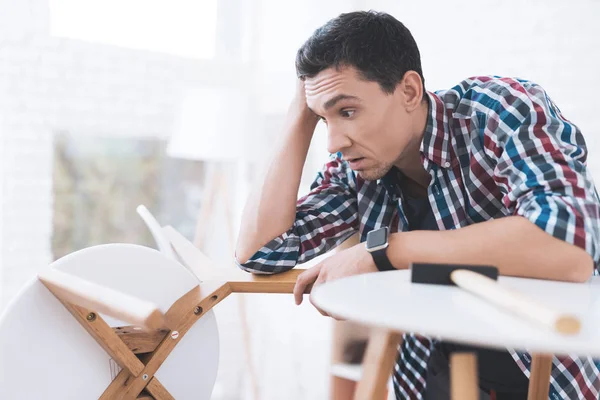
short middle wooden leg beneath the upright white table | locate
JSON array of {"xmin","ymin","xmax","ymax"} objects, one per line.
[{"xmin": 450, "ymin": 353, "xmax": 479, "ymax": 400}]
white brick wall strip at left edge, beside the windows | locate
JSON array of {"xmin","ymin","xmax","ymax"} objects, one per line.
[{"xmin": 0, "ymin": 1, "xmax": 51, "ymax": 308}]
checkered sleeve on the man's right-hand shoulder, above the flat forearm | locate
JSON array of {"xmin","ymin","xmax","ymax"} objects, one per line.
[{"xmin": 487, "ymin": 81, "xmax": 600, "ymax": 268}]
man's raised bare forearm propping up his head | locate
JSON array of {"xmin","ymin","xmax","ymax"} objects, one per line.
[{"xmin": 236, "ymin": 112, "xmax": 317, "ymax": 263}]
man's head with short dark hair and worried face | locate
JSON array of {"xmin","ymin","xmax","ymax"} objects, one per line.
[{"xmin": 296, "ymin": 11, "xmax": 426, "ymax": 180}]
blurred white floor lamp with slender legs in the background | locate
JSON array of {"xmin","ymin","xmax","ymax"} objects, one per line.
[{"xmin": 167, "ymin": 88, "xmax": 259, "ymax": 400}]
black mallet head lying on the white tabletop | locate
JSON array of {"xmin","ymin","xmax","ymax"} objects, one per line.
[{"xmin": 410, "ymin": 263, "xmax": 498, "ymax": 286}]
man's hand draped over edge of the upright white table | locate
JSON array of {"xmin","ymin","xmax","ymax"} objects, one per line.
[{"xmin": 294, "ymin": 243, "xmax": 377, "ymax": 316}]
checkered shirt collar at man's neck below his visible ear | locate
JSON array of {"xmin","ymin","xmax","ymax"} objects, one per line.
[{"xmin": 421, "ymin": 92, "xmax": 457, "ymax": 168}]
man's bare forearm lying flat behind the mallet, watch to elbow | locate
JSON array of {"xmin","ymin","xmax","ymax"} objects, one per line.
[{"xmin": 387, "ymin": 216, "xmax": 593, "ymax": 282}]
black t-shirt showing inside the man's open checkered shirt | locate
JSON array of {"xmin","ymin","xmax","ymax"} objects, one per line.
[{"xmin": 390, "ymin": 169, "xmax": 529, "ymax": 393}]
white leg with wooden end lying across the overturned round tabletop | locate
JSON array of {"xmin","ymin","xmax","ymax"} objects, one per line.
[{"xmin": 38, "ymin": 269, "xmax": 166, "ymax": 329}]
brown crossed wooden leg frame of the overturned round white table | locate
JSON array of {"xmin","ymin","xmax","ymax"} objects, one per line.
[{"xmin": 38, "ymin": 227, "xmax": 310, "ymax": 400}]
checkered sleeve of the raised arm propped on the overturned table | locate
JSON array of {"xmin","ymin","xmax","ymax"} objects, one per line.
[{"xmin": 237, "ymin": 156, "xmax": 358, "ymax": 274}]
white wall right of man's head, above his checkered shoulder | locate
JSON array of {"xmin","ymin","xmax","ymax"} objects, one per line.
[{"xmin": 369, "ymin": 0, "xmax": 600, "ymax": 173}]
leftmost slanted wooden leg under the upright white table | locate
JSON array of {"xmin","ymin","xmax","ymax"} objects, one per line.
[{"xmin": 354, "ymin": 330, "xmax": 402, "ymax": 400}]
